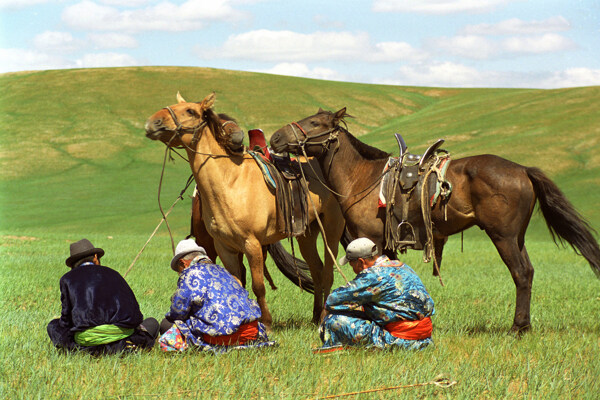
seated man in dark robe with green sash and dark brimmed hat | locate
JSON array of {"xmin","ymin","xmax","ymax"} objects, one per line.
[{"xmin": 47, "ymin": 239, "xmax": 158, "ymax": 355}]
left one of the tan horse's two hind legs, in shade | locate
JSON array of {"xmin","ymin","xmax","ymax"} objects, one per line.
[{"xmin": 296, "ymin": 222, "xmax": 324, "ymax": 324}]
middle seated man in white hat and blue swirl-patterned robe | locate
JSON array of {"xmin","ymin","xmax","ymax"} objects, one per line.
[{"xmin": 158, "ymin": 239, "xmax": 275, "ymax": 352}]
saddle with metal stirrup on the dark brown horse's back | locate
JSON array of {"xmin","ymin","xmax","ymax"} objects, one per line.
[{"xmin": 380, "ymin": 134, "xmax": 452, "ymax": 262}]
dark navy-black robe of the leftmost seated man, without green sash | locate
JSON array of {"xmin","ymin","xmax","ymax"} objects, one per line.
[{"xmin": 48, "ymin": 264, "xmax": 154, "ymax": 354}]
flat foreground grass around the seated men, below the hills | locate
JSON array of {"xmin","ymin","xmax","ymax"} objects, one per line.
[{"xmin": 0, "ymin": 231, "xmax": 600, "ymax": 399}]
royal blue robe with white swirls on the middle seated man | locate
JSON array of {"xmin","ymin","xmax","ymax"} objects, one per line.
[{"xmin": 161, "ymin": 259, "xmax": 274, "ymax": 350}]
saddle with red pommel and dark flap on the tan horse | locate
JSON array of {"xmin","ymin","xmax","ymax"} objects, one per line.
[{"xmin": 248, "ymin": 129, "xmax": 308, "ymax": 237}]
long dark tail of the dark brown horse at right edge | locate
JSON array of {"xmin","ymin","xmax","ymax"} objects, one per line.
[{"xmin": 526, "ymin": 168, "xmax": 600, "ymax": 278}]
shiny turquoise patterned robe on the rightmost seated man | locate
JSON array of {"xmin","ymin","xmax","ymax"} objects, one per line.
[{"xmin": 319, "ymin": 256, "xmax": 434, "ymax": 349}]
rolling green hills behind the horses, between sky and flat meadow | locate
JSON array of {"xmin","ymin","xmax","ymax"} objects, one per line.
[{"xmin": 0, "ymin": 67, "xmax": 600, "ymax": 234}]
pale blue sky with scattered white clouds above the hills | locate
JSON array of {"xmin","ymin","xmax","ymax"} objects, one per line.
[{"xmin": 0, "ymin": 0, "xmax": 600, "ymax": 89}]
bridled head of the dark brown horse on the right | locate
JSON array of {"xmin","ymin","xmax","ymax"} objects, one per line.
[{"xmin": 270, "ymin": 107, "xmax": 350, "ymax": 157}]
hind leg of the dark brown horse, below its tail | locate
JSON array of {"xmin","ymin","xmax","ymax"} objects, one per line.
[{"xmin": 492, "ymin": 238, "xmax": 533, "ymax": 334}]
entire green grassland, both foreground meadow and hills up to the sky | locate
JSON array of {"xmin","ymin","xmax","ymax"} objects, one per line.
[{"xmin": 0, "ymin": 68, "xmax": 600, "ymax": 399}]
